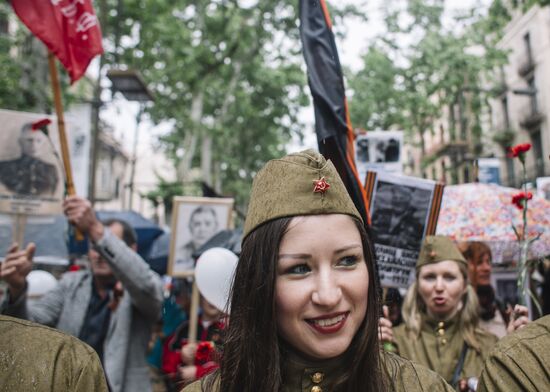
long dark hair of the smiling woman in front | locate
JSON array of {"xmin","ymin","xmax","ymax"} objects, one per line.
[{"xmin": 203, "ymin": 218, "xmax": 387, "ymax": 392}]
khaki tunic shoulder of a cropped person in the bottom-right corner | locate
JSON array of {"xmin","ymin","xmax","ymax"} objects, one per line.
[{"xmin": 477, "ymin": 315, "xmax": 550, "ymax": 392}]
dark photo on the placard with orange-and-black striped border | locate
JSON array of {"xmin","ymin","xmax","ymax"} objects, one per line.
[{"xmin": 372, "ymin": 181, "xmax": 431, "ymax": 250}]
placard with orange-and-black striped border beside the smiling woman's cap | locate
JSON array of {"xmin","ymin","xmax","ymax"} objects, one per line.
[{"xmin": 365, "ymin": 172, "xmax": 443, "ymax": 287}]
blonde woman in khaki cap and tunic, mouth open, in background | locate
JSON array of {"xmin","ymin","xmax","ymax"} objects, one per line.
[{"xmin": 380, "ymin": 236, "xmax": 528, "ymax": 390}]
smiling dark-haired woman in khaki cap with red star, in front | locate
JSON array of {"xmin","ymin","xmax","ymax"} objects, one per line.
[{"xmin": 184, "ymin": 150, "xmax": 451, "ymax": 392}]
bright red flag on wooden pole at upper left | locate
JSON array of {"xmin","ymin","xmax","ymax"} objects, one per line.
[{"xmin": 11, "ymin": 0, "xmax": 103, "ymax": 83}]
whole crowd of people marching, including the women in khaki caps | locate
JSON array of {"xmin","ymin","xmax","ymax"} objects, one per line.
[{"xmin": 0, "ymin": 150, "xmax": 550, "ymax": 392}]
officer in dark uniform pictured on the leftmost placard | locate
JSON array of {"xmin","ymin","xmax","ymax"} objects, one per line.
[{"xmin": 0, "ymin": 121, "xmax": 59, "ymax": 197}]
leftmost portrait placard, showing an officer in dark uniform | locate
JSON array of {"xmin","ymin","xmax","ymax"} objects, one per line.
[{"xmin": 0, "ymin": 110, "xmax": 64, "ymax": 215}]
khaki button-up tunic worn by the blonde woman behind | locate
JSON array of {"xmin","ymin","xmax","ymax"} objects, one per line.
[{"xmin": 393, "ymin": 316, "xmax": 497, "ymax": 383}]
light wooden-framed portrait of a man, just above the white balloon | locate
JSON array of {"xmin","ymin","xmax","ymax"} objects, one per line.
[{"xmin": 168, "ymin": 196, "xmax": 234, "ymax": 276}]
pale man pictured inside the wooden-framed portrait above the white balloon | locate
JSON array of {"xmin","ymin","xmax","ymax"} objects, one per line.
[{"xmin": 174, "ymin": 205, "xmax": 220, "ymax": 271}]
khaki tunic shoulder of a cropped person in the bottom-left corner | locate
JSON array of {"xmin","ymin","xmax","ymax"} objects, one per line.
[{"xmin": 0, "ymin": 316, "xmax": 108, "ymax": 392}]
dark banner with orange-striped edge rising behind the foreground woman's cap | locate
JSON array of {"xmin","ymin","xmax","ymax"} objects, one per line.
[{"xmin": 300, "ymin": 0, "xmax": 370, "ymax": 224}]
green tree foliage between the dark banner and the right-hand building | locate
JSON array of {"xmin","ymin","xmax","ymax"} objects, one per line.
[{"xmin": 350, "ymin": 0, "xmax": 509, "ymax": 175}]
